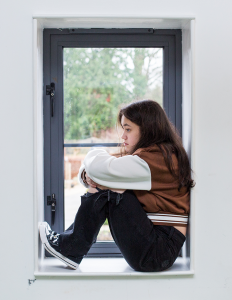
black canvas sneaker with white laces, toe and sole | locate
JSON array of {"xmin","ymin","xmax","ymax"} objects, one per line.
[{"xmin": 39, "ymin": 222, "xmax": 79, "ymax": 270}]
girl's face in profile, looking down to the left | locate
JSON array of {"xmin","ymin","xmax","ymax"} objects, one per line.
[{"xmin": 121, "ymin": 115, "xmax": 141, "ymax": 154}]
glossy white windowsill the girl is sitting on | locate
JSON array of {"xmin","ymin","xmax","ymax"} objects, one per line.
[{"xmin": 34, "ymin": 258, "xmax": 194, "ymax": 277}]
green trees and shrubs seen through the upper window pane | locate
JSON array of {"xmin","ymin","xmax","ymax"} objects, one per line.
[{"xmin": 64, "ymin": 48, "xmax": 162, "ymax": 140}]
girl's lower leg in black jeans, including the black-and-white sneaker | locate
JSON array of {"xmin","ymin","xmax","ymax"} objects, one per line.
[{"xmin": 39, "ymin": 191, "xmax": 109, "ymax": 269}]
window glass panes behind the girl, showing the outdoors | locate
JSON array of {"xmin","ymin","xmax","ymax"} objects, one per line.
[{"xmin": 63, "ymin": 48, "xmax": 163, "ymax": 241}]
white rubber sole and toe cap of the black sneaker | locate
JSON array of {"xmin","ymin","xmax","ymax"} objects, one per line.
[{"xmin": 39, "ymin": 222, "xmax": 79, "ymax": 270}]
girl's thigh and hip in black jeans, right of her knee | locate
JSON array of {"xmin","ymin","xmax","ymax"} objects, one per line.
[{"xmin": 109, "ymin": 191, "xmax": 185, "ymax": 272}]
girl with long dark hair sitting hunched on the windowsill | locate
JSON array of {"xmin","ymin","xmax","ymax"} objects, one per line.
[{"xmin": 40, "ymin": 100, "xmax": 194, "ymax": 272}]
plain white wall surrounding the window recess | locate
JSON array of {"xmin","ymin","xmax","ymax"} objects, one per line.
[{"xmin": 0, "ymin": 0, "xmax": 232, "ymax": 300}]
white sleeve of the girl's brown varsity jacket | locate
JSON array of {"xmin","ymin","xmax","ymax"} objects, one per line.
[{"xmin": 79, "ymin": 149, "xmax": 151, "ymax": 191}]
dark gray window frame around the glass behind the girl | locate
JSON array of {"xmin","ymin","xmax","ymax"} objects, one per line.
[{"xmin": 43, "ymin": 28, "xmax": 182, "ymax": 257}]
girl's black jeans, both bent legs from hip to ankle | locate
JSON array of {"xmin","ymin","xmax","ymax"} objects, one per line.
[{"xmin": 60, "ymin": 190, "xmax": 185, "ymax": 272}]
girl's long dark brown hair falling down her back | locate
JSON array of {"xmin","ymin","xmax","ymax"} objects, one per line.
[{"xmin": 118, "ymin": 100, "xmax": 195, "ymax": 190}]
